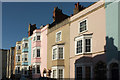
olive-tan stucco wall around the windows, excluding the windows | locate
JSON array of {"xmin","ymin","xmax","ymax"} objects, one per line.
[{"xmin": 47, "ymin": 18, "xmax": 70, "ymax": 78}]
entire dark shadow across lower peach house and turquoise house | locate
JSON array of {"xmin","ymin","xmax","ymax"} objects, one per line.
[{"xmin": 75, "ymin": 37, "xmax": 120, "ymax": 80}]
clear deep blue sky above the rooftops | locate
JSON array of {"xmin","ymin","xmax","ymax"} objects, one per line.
[{"xmin": 2, "ymin": 2, "xmax": 92, "ymax": 49}]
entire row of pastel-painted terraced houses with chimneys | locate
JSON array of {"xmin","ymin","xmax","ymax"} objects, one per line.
[{"xmin": 4, "ymin": 1, "xmax": 120, "ymax": 80}]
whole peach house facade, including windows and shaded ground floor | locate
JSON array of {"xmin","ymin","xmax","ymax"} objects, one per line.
[{"xmin": 70, "ymin": 1, "xmax": 106, "ymax": 80}]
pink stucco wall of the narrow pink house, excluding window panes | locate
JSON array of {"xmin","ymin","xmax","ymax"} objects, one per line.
[{"xmin": 31, "ymin": 25, "xmax": 48, "ymax": 77}]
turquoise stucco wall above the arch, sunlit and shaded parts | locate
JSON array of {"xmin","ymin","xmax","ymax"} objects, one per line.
[{"xmin": 105, "ymin": 2, "xmax": 120, "ymax": 63}]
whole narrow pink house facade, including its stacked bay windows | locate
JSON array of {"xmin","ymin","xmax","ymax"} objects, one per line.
[{"xmin": 31, "ymin": 25, "xmax": 48, "ymax": 78}]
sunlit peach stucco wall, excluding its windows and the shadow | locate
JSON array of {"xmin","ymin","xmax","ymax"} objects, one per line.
[{"xmin": 70, "ymin": 2, "xmax": 106, "ymax": 78}]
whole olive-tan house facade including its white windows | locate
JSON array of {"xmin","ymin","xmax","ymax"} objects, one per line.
[{"xmin": 47, "ymin": 10, "xmax": 70, "ymax": 78}]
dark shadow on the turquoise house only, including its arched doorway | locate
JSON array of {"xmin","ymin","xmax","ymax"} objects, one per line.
[{"xmin": 105, "ymin": 36, "xmax": 120, "ymax": 80}]
